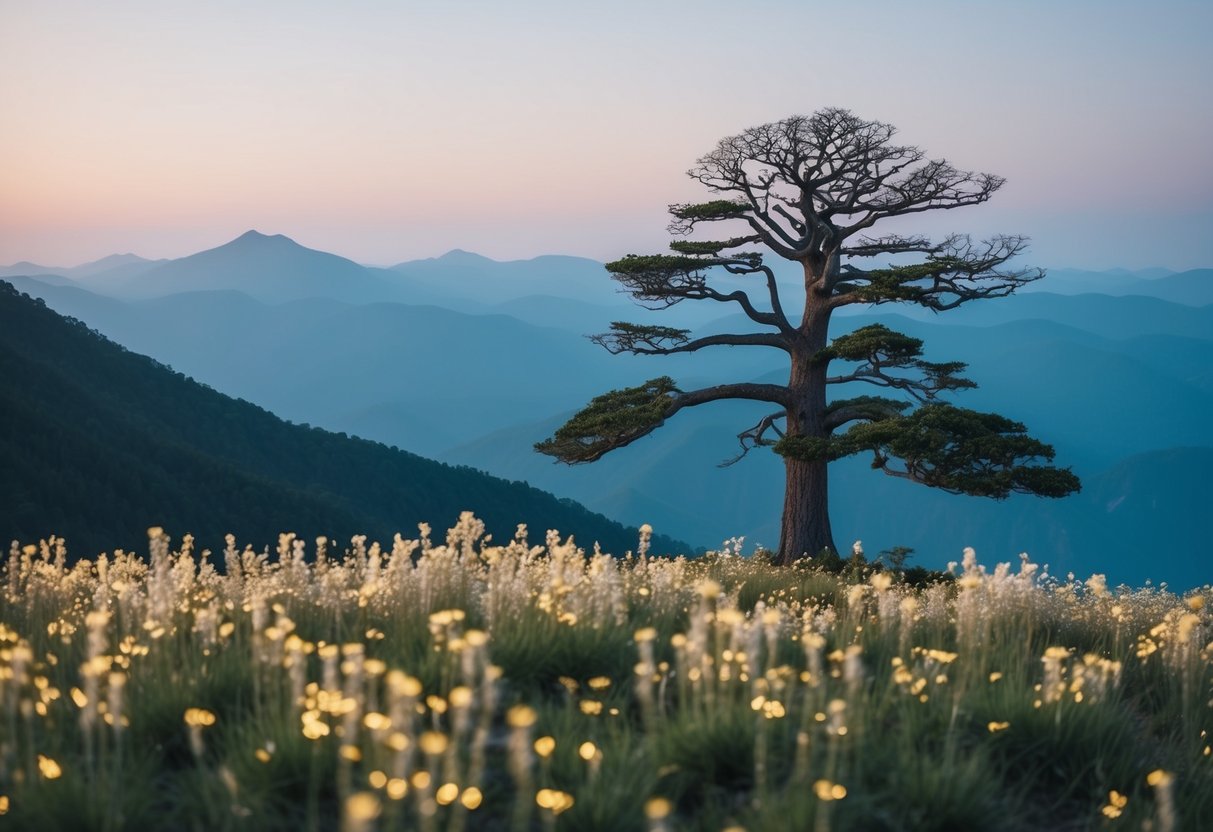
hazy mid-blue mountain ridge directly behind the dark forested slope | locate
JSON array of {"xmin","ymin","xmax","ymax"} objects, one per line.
[{"xmin": 13, "ymin": 278, "xmax": 651, "ymax": 463}]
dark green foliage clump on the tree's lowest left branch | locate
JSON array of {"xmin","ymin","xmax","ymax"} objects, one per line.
[{"xmin": 535, "ymin": 376, "xmax": 678, "ymax": 463}]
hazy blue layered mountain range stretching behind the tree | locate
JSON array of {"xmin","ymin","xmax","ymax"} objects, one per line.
[{"xmin": 4, "ymin": 232, "xmax": 1213, "ymax": 585}]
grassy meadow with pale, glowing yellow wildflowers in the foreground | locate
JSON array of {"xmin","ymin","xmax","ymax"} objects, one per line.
[{"xmin": 0, "ymin": 514, "xmax": 1213, "ymax": 832}]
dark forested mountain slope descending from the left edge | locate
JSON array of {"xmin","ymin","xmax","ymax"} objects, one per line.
[{"xmin": 0, "ymin": 283, "xmax": 685, "ymax": 555}]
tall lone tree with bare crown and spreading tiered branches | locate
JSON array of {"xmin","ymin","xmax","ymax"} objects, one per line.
[{"xmin": 535, "ymin": 109, "xmax": 1080, "ymax": 563}]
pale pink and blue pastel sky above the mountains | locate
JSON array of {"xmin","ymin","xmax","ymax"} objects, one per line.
[{"xmin": 0, "ymin": 0, "xmax": 1213, "ymax": 269}]
